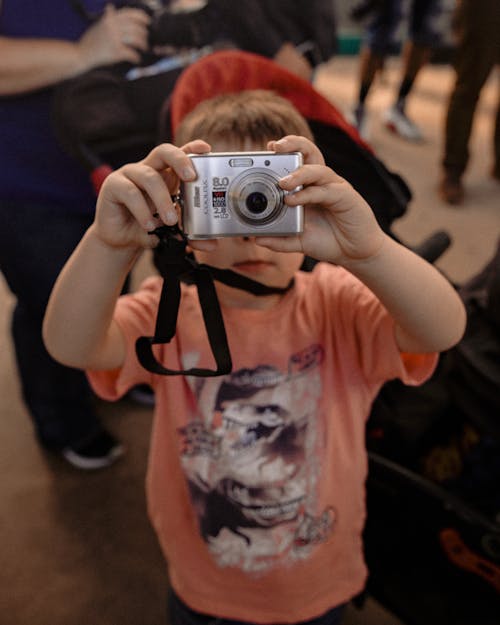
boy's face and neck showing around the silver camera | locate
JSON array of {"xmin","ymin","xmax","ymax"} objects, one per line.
[{"xmin": 189, "ymin": 142, "xmax": 304, "ymax": 308}]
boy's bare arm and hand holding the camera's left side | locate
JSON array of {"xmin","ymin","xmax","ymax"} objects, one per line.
[{"xmin": 43, "ymin": 141, "xmax": 212, "ymax": 369}]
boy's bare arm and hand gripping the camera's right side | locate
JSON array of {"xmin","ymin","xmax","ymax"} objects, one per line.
[{"xmin": 257, "ymin": 136, "xmax": 465, "ymax": 352}]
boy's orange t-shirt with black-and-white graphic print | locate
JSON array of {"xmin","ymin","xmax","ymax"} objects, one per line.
[{"xmin": 89, "ymin": 263, "xmax": 436, "ymax": 623}]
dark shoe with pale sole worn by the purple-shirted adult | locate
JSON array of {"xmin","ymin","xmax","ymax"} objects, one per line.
[{"xmin": 61, "ymin": 429, "xmax": 125, "ymax": 471}]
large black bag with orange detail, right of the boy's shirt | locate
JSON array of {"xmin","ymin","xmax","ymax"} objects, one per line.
[{"xmin": 365, "ymin": 244, "xmax": 500, "ymax": 625}]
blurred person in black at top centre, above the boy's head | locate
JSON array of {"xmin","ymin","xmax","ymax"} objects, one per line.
[{"xmin": 153, "ymin": 0, "xmax": 336, "ymax": 80}]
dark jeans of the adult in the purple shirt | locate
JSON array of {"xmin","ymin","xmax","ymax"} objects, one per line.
[{"xmin": 0, "ymin": 201, "xmax": 100, "ymax": 449}]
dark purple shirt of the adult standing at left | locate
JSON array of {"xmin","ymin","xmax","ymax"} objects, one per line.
[{"xmin": 0, "ymin": 0, "xmax": 111, "ymax": 212}]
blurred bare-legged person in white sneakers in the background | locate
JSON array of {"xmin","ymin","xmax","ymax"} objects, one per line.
[{"xmin": 348, "ymin": 0, "xmax": 440, "ymax": 142}]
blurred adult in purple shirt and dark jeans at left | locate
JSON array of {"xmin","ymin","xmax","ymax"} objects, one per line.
[{"xmin": 0, "ymin": 0, "xmax": 150, "ymax": 469}]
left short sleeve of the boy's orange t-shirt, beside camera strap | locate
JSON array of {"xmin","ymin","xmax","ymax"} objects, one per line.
[{"xmin": 86, "ymin": 277, "xmax": 160, "ymax": 401}]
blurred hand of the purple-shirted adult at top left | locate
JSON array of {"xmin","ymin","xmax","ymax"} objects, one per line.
[{"xmin": 77, "ymin": 4, "xmax": 151, "ymax": 71}]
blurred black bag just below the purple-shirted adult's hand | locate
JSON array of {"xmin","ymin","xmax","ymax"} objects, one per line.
[{"xmin": 52, "ymin": 50, "xmax": 210, "ymax": 171}]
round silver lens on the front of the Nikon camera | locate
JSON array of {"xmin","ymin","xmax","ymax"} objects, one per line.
[{"xmin": 228, "ymin": 168, "xmax": 285, "ymax": 228}]
